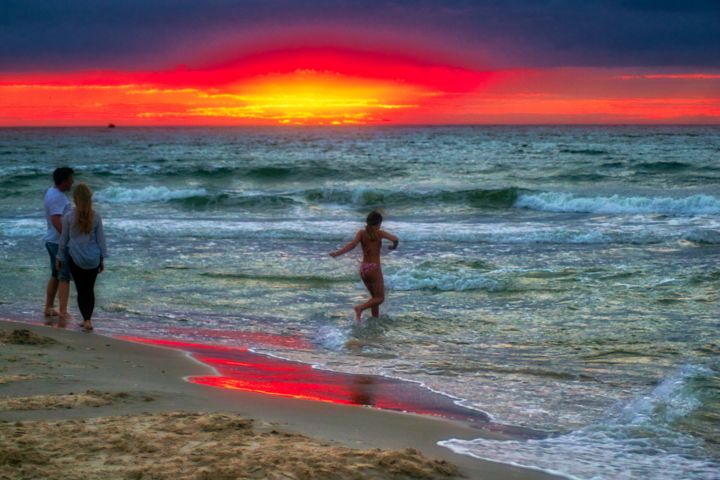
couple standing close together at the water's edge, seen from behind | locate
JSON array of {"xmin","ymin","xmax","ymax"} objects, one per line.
[{"xmin": 44, "ymin": 167, "xmax": 107, "ymax": 332}]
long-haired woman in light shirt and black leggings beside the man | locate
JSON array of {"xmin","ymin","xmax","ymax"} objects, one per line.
[{"xmin": 57, "ymin": 183, "xmax": 107, "ymax": 332}]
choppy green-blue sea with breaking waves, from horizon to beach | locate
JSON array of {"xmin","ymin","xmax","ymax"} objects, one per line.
[{"xmin": 0, "ymin": 127, "xmax": 720, "ymax": 479}]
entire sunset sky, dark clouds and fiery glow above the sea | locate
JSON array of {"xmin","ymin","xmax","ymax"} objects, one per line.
[{"xmin": 0, "ymin": 0, "xmax": 720, "ymax": 126}]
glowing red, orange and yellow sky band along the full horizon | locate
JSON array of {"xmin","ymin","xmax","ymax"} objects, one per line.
[{"xmin": 0, "ymin": 48, "xmax": 720, "ymax": 126}]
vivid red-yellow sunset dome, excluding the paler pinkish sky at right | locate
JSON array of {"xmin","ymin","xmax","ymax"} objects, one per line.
[{"xmin": 0, "ymin": 49, "xmax": 462, "ymax": 125}]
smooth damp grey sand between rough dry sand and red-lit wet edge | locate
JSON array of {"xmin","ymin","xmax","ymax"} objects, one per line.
[{"xmin": 0, "ymin": 319, "xmax": 558, "ymax": 480}]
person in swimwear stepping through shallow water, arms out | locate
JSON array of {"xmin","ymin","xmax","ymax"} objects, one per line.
[{"xmin": 330, "ymin": 211, "xmax": 400, "ymax": 321}]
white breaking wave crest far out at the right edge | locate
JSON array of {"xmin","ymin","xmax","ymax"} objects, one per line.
[{"xmin": 515, "ymin": 192, "xmax": 720, "ymax": 215}]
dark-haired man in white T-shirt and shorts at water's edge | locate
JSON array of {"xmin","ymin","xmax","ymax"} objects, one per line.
[{"xmin": 44, "ymin": 167, "xmax": 75, "ymax": 327}]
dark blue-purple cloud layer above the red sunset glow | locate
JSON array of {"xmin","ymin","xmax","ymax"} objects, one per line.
[{"xmin": 0, "ymin": 0, "xmax": 720, "ymax": 71}]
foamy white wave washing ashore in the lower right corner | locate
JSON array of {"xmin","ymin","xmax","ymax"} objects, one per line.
[{"xmin": 439, "ymin": 365, "xmax": 720, "ymax": 480}]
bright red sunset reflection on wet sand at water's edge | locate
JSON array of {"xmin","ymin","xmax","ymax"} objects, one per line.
[{"xmin": 120, "ymin": 337, "xmax": 488, "ymax": 423}]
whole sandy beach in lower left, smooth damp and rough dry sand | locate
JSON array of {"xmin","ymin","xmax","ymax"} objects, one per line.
[{"xmin": 0, "ymin": 321, "xmax": 551, "ymax": 479}]
